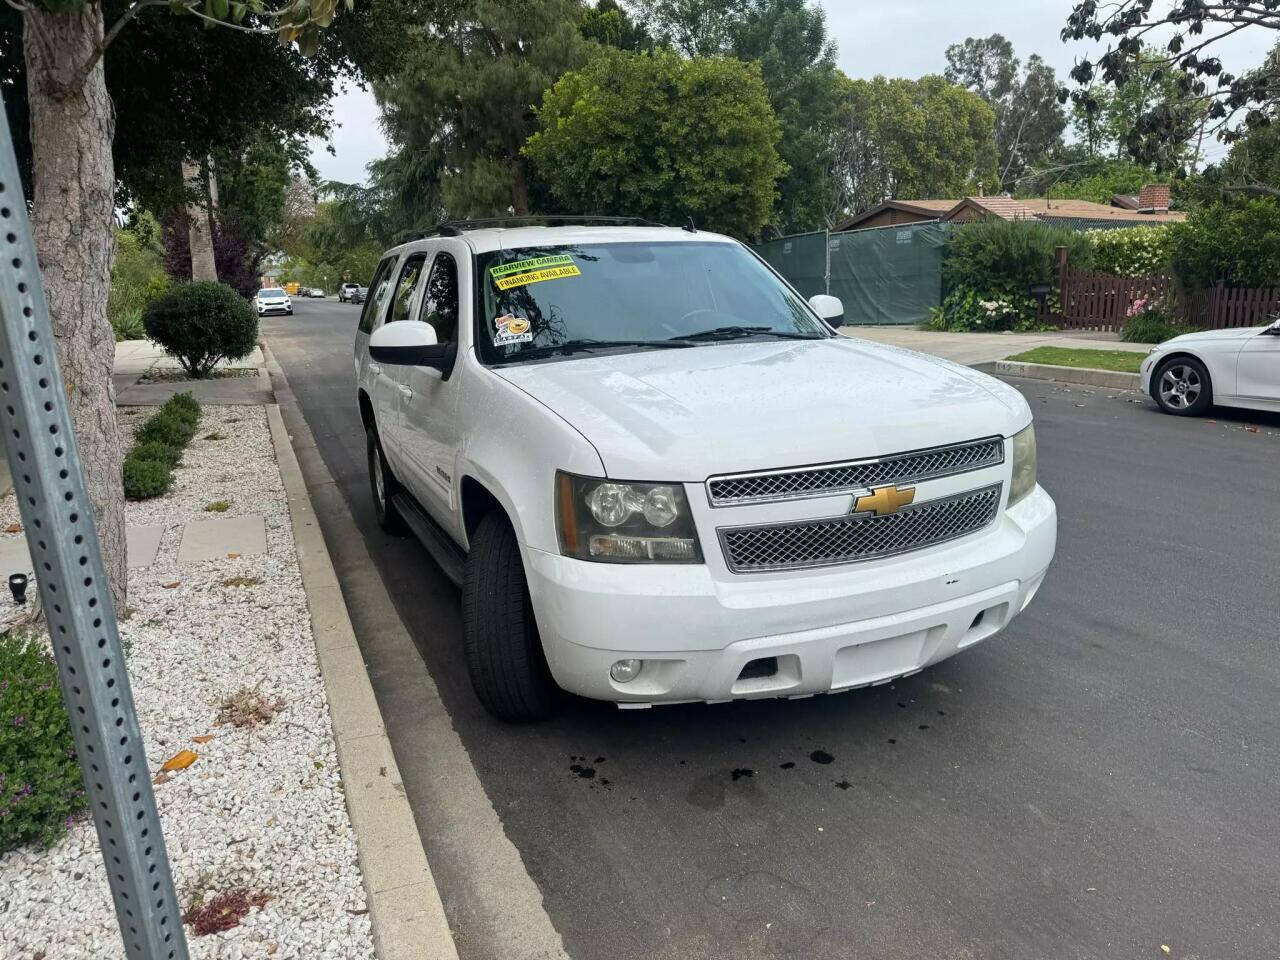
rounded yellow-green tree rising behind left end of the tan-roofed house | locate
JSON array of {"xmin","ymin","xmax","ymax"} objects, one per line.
[{"xmin": 835, "ymin": 77, "xmax": 998, "ymax": 217}]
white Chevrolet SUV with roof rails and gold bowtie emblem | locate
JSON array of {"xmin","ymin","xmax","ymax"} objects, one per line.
[{"xmin": 355, "ymin": 224, "xmax": 1057, "ymax": 719}]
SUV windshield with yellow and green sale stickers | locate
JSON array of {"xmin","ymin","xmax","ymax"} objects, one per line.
[{"xmin": 476, "ymin": 242, "xmax": 831, "ymax": 364}]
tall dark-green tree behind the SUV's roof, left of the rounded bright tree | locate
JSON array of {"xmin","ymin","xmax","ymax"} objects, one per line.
[{"xmin": 374, "ymin": 0, "xmax": 588, "ymax": 216}]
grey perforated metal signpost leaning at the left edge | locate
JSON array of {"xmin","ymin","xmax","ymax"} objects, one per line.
[{"xmin": 0, "ymin": 99, "xmax": 187, "ymax": 960}]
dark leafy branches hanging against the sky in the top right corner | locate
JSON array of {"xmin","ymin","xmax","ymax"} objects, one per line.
[{"xmin": 1061, "ymin": 0, "xmax": 1280, "ymax": 159}]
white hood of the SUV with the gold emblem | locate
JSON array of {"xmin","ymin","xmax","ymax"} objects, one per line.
[{"xmin": 494, "ymin": 337, "xmax": 1030, "ymax": 483}]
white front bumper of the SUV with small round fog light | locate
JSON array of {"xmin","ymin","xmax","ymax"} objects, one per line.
[{"xmin": 526, "ymin": 486, "xmax": 1057, "ymax": 707}]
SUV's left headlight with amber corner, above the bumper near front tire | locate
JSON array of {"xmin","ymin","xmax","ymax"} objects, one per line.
[{"xmin": 556, "ymin": 471, "xmax": 703, "ymax": 563}]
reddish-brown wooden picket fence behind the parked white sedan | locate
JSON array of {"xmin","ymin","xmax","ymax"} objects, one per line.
[{"xmin": 1042, "ymin": 247, "xmax": 1280, "ymax": 332}]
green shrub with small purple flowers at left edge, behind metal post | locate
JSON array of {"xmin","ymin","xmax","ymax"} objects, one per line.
[{"xmin": 0, "ymin": 632, "xmax": 84, "ymax": 854}]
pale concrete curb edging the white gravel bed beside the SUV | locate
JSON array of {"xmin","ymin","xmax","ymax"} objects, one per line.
[{"xmin": 266, "ymin": 403, "xmax": 458, "ymax": 960}]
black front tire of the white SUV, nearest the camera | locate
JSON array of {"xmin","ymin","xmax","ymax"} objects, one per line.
[{"xmin": 462, "ymin": 512, "xmax": 562, "ymax": 723}]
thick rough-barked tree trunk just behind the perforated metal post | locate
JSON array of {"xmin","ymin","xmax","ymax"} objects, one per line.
[{"xmin": 23, "ymin": 4, "xmax": 128, "ymax": 613}]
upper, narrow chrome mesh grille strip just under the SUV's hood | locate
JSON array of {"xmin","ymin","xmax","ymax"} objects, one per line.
[{"xmin": 707, "ymin": 436, "xmax": 1005, "ymax": 507}]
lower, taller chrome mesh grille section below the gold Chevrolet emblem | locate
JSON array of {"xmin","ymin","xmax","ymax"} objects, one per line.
[{"xmin": 718, "ymin": 484, "xmax": 1001, "ymax": 573}]
